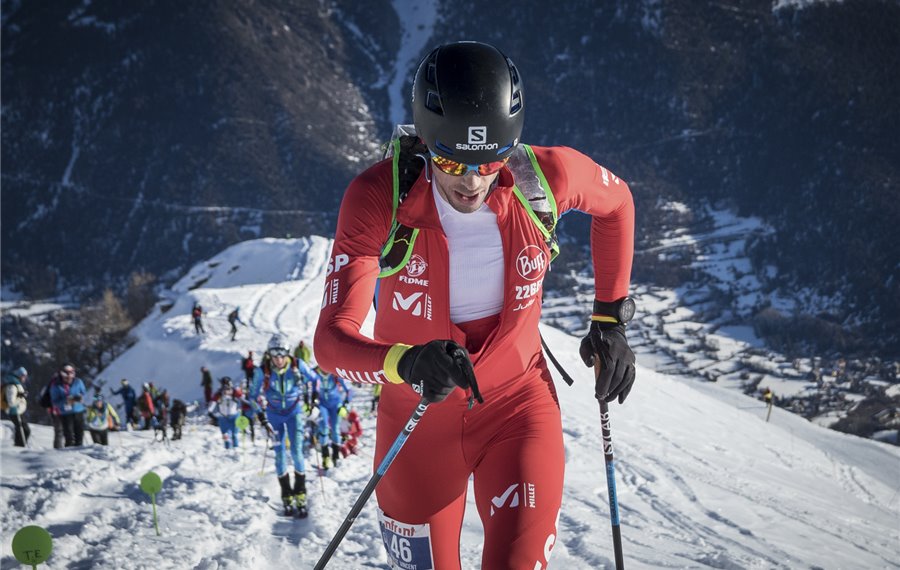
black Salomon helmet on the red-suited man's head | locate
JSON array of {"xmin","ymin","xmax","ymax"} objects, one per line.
[{"xmin": 412, "ymin": 42, "xmax": 525, "ymax": 164}]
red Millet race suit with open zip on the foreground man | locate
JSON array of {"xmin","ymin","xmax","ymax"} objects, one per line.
[{"xmin": 315, "ymin": 143, "xmax": 634, "ymax": 569}]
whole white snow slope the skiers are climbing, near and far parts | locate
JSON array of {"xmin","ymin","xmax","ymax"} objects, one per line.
[{"xmin": 0, "ymin": 238, "xmax": 900, "ymax": 569}]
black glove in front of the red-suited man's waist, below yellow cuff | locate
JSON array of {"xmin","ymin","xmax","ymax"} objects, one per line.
[{"xmin": 397, "ymin": 340, "xmax": 483, "ymax": 404}]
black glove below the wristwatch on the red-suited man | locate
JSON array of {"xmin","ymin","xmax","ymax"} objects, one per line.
[{"xmin": 579, "ymin": 321, "xmax": 634, "ymax": 404}]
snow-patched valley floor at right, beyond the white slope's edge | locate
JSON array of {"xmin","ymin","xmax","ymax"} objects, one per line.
[{"xmin": 543, "ymin": 203, "xmax": 900, "ymax": 443}]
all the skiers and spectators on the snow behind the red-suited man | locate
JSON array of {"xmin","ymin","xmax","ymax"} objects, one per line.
[{"xmin": 2, "ymin": 328, "xmax": 370, "ymax": 517}]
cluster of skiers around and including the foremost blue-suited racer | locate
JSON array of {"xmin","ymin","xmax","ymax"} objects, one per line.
[{"xmin": 200, "ymin": 334, "xmax": 370, "ymax": 518}]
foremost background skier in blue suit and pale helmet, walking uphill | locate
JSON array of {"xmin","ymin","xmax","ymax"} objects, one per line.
[{"xmin": 250, "ymin": 334, "xmax": 318, "ymax": 517}]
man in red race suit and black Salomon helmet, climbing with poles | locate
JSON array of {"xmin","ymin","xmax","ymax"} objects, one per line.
[{"xmin": 315, "ymin": 42, "xmax": 634, "ymax": 569}]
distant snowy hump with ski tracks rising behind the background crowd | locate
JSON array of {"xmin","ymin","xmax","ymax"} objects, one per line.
[{"xmin": 100, "ymin": 236, "xmax": 331, "ymax": 401}]
